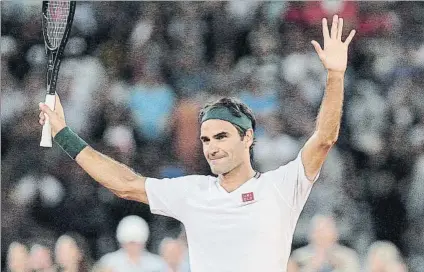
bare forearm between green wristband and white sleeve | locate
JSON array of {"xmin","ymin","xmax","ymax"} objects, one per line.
[{"xmin": 75, "ymin": 146, "xmax": 147, "ymax": 203}]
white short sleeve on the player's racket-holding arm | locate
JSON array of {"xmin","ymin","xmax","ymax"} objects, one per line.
[{"xmin": 146, "ymin": 175, "xmax": 207, "ymax": 221}]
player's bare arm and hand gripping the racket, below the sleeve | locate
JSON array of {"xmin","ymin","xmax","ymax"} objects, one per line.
[{"xmin": 39, "ymin": 95, "xmax": 149, "ymax": 204}]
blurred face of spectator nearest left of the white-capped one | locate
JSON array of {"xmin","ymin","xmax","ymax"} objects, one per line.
[{"xmin": 55, "ymin": 238, "xmax": 82, "ymax": 267}]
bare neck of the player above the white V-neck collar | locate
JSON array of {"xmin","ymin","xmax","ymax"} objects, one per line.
[{"xmin": 219, "ymin": 163, "xmax": 256, "ymax": 192}]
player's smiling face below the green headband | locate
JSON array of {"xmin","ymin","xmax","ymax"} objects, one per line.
[{"xmin": 200, "ymin": 119, "xmax": 253, "ymax": 175}]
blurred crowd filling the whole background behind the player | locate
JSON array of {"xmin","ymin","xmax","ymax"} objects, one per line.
[{"xmin": 1, "ymin": 0, "xmax": 424, "ymax": 272}]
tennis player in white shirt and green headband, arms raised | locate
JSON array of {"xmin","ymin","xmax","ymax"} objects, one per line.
[{"xmin": 40, "ymin": 15, "xmax": 355, "ymax": 272}]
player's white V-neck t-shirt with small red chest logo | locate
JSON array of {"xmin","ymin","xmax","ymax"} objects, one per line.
[{"xmin": 146, "ymin": 152, "xmax": 318, "ymax": 272}]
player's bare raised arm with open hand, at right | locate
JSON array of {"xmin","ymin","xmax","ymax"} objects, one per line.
[{"xmin": 301, "ymin": 15, "xmax": 355, "ymax": 182}]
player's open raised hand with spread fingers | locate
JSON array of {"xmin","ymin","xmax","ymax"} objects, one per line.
[{"xmin": 312, "ymin": 15, "xmax": 355, "ymax": 72}]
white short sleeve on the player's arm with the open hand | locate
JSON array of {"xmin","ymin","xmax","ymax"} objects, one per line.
[{"xmin": 269, "ymin": 150, "xmax": 319, "ymax": 211}]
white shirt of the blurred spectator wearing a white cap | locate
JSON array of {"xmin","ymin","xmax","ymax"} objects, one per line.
[{"xmin": 99, "ymin": 248, "xmax": 169, "ymax": 272}]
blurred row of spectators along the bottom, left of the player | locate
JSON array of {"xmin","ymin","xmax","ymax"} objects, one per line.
[{"xmin": 5, "ymin": 215, "xmax": 189, "ymax": 272}]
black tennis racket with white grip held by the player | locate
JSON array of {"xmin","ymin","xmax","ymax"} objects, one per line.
[{"xmin": 40, "ymin": 1, "xmax": 76, "ymax": 147}]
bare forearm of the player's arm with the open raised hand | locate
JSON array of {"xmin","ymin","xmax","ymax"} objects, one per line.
[{"xmin": 316, "ymin": 71, "xmax": 344, "ymax": 144}]
